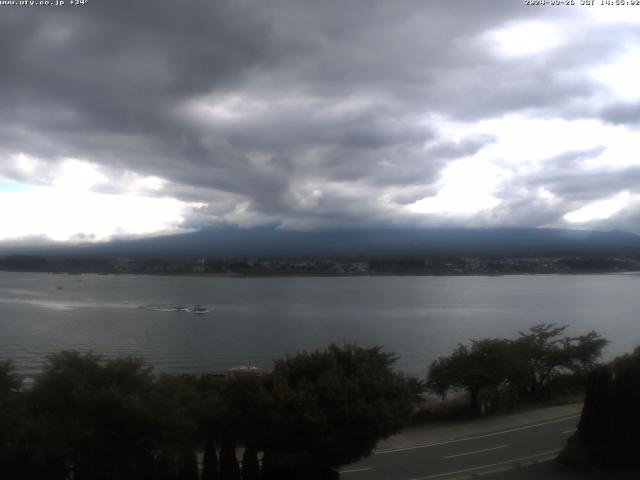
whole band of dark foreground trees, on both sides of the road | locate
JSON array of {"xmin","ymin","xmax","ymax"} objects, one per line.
[{"xmin": 0, "ymin": 324, "xmax": 624, "ymax": 480}]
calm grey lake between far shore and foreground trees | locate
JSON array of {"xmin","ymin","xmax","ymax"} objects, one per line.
[{"xmin": 0, "ymin": 272, "xmax": 640, "ymax": 375}]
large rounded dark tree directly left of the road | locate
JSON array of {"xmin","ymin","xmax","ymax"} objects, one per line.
[{"xmin": 263, "ymin": 345, "xmax": 413, "ymax": 478}]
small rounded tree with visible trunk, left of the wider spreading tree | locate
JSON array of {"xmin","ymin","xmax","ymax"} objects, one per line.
[{"xmin": 427, "ymin": 339, "xmax": 511, "ymax": 416}]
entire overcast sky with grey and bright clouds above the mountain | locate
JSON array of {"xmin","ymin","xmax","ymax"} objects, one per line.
[{"xmin": 0, "ymin": 0, "xmax": 640, "ymax": 241}]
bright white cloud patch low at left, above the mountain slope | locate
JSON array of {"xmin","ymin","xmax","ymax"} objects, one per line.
[{"xmin": 0, "ymin": 160, "xmax": 203, "ymax": 241}]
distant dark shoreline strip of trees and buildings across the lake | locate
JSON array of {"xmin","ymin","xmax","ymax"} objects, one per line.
[{"xmin": 0, "ymin": 255, "xmax": 640, "ymax": 276}]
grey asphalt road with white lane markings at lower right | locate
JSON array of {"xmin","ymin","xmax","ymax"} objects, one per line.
[{"xmin": 340, "ymin": 415, "xmax": 579, "ymax": 480}]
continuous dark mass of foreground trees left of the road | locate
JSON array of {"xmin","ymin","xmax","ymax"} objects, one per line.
[{"xmin": 0, "ymin": 345, "xmax": 416, "ymax": 480}]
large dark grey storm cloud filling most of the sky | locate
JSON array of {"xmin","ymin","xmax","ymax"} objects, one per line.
[{"xmin": 0, "ymin": 0, "xmax": 637, "ymax": 232}]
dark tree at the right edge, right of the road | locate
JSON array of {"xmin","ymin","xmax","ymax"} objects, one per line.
[{"xmin": 561, "ymin": 347, "xmax": 640, "ymax": 468}]
